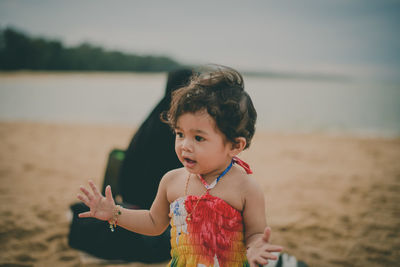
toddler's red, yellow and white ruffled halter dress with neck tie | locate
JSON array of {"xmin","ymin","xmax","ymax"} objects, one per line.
[{"xmin": 168, "ymin": 158, "xmax": 251, "ymax": 267}]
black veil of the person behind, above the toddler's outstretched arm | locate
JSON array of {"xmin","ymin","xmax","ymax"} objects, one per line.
[{"xmin": 118, "ymin": 69, "xmax": 192, "ymax": 209}]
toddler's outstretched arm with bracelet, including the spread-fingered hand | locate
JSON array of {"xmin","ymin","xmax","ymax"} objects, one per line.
[{"xmin": 78, "ymin": 174, "xmax": 169, "ymax": 235}]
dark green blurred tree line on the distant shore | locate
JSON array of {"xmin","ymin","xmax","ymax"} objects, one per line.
[{"xmin": 0, "ymin": 28, "xmax": 181, "ymax": 72}]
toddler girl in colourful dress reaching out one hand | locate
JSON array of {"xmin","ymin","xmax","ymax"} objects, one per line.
[{"xmin": 78, "ymin": 66, "xmax": 282, "ymax": 267}]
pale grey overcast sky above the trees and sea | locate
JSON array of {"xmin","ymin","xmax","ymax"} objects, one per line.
[{"xmin": 0, "ymin": 0, "xmax": 400, "ymax": 77}]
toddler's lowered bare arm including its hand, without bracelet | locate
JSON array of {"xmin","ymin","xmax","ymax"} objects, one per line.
[{"xmin": 243, "ymin": 179, "xmax": 282, "ymax": 267}]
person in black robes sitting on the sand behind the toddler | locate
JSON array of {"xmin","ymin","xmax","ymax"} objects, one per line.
[{"xmin": 68, "ymin": 69, "xmax": 192, "ymax": 263}]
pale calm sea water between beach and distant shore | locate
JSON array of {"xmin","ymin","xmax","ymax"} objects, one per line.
[{"xmin": 0, "ymin": 72, "xmax": 400, "ymax": 136}]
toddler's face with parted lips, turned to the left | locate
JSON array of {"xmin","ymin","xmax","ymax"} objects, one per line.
[{"xmin": 175, "ymin": 111, "xmax": 234, "ymax": 179}]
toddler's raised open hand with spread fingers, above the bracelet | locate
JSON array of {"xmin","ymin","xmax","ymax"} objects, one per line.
[{"xmin": 78, "ymin": 181, "xmax": 115, "ymax": 221}]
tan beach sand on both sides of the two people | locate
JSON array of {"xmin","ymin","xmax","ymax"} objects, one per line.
[{"xmin": 0, "ymin": 122, "xmax": 400, "ymax": 267}]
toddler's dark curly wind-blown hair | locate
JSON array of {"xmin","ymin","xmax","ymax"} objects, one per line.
[{"xmin": 161, "ymin": 65, "xmax": 257, "ymax": 148}]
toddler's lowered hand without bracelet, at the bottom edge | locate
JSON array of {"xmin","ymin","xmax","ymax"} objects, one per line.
[{"xmin": 247, "ymin": 227, "xmax": 283, "ymax": 267}]
